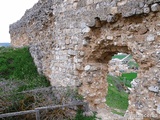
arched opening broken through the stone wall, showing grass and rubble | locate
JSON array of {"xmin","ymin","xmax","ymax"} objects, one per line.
[{"xmin": 106, "ymin": 53, "xmax": 138, "ymax": 116}]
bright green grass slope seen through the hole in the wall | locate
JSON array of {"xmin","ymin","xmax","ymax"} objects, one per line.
[{"xmin": 106, "ymin": 73, "xmax": 137, "ymax": 116}]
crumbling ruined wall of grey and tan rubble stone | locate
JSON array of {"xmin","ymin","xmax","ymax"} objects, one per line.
[{"xmin": 10, "ymin": 0, "xmax": 160, "ymax": 118}]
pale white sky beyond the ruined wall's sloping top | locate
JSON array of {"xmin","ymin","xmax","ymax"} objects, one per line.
[{"xmin": 0, "ymin": 0, "xmax": 38, "ymax": 43}]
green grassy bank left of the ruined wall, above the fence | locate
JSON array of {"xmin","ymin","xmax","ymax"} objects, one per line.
[{"xmin": 0, "ymin": 47, "xmax": 50, "ymax": 93}]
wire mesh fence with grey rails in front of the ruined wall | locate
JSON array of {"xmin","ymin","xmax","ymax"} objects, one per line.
[{"xmin": 0, "ymin": 86, "xmax": 88, "ymax": 120}]
